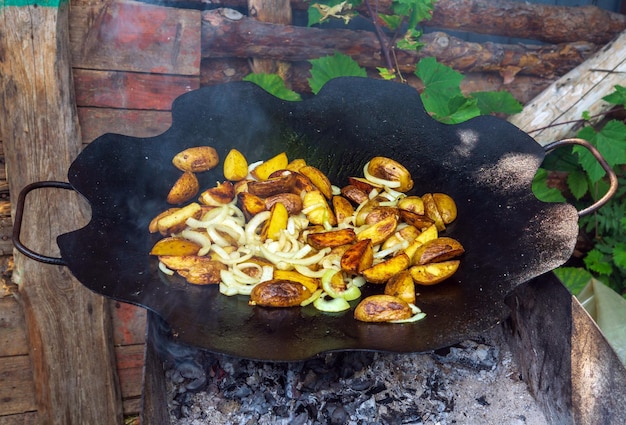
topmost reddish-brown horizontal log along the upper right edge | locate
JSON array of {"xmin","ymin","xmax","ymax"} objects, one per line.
[{"xmin": 195, "ymin": 0, "xmax": 626, "ymax": 45}]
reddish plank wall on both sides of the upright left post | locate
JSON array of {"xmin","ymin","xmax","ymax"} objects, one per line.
[{"xmin": 0, "ymin": 0, "xmax": 201, "ymax": 425}]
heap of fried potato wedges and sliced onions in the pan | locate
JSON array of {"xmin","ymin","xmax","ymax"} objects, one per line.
[{"xmin": 149, "ymin": 146, "xmax": 464, "ymax": 323}]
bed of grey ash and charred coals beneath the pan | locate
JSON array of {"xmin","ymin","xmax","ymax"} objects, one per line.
[{"xmin": 166, "ymin": 328, "xmax": 547, "ymax": 425}]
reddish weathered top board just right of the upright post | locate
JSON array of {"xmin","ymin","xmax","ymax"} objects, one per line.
[{"xmin": 70, "ymin": 0, "xmax": 200, "ymax": 75}]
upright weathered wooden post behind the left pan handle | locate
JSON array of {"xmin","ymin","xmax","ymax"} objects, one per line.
[{"xmin": 0, "ymin": 0, "xmax": 123, "ymax": 425}]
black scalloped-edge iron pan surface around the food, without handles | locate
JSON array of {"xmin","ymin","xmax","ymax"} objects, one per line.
[{"xmin": 58, "ymin": 78, "xmax": 578, "ymax": 361}]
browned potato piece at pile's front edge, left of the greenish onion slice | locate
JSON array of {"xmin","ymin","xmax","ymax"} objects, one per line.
[{"xmin": 250, "ymin": 279, "xmax": 311, "ymax": 307}]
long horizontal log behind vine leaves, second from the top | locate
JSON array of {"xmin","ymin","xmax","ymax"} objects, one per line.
[{"xmin": 202, "ymin": 9, "xmax": 596, "ymax": 81}]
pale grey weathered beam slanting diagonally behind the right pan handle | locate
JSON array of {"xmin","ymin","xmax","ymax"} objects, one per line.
[{"xmin": 509, "ymin": 32, "xmax": 626, "ymax": 144}]
